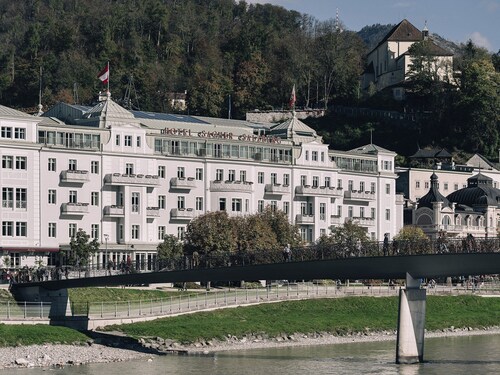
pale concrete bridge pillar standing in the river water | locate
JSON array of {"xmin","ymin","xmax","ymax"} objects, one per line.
[{"xmin": 396, "ymin": 273, "xmax": 426, "ymax": 364}]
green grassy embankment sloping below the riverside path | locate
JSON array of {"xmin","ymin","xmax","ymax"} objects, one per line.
[{"xmin": 0, "ymin": 288, "xmax": 500, "ymax": 346}]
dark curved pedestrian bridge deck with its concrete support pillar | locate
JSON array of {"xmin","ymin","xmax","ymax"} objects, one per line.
[{"xmin": 11, "ymin": 252, "xmax": 500, "ymax": 363}]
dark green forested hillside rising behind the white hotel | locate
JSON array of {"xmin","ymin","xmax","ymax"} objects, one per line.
[{"xmin": 0, "ymin": 0, "xmax": 500, "ymax": 163}]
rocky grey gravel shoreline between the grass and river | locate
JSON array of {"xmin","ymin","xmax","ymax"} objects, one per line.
[{"xmin": 0, "ymin": 326, "xmax": 500, "ymax": 374}]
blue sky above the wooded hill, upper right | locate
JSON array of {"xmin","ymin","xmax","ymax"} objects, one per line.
[{"xmin": 246, "ymin": 0, "xmax": 500, "ymax": 52}]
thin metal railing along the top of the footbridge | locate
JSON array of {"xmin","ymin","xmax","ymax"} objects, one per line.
[{"xmin": 10, "ymin": 236, "xmax": 500, "ymax": 283}]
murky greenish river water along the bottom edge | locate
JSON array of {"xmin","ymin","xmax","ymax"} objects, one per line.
[{"xmin": 6, "ymin": 335, "xmax": 500, "ymax": 375}]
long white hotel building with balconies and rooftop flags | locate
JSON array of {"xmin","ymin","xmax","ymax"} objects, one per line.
[{"xmin": 0, "ymin": 96, "xmax": 403, "ymax": 268}]
